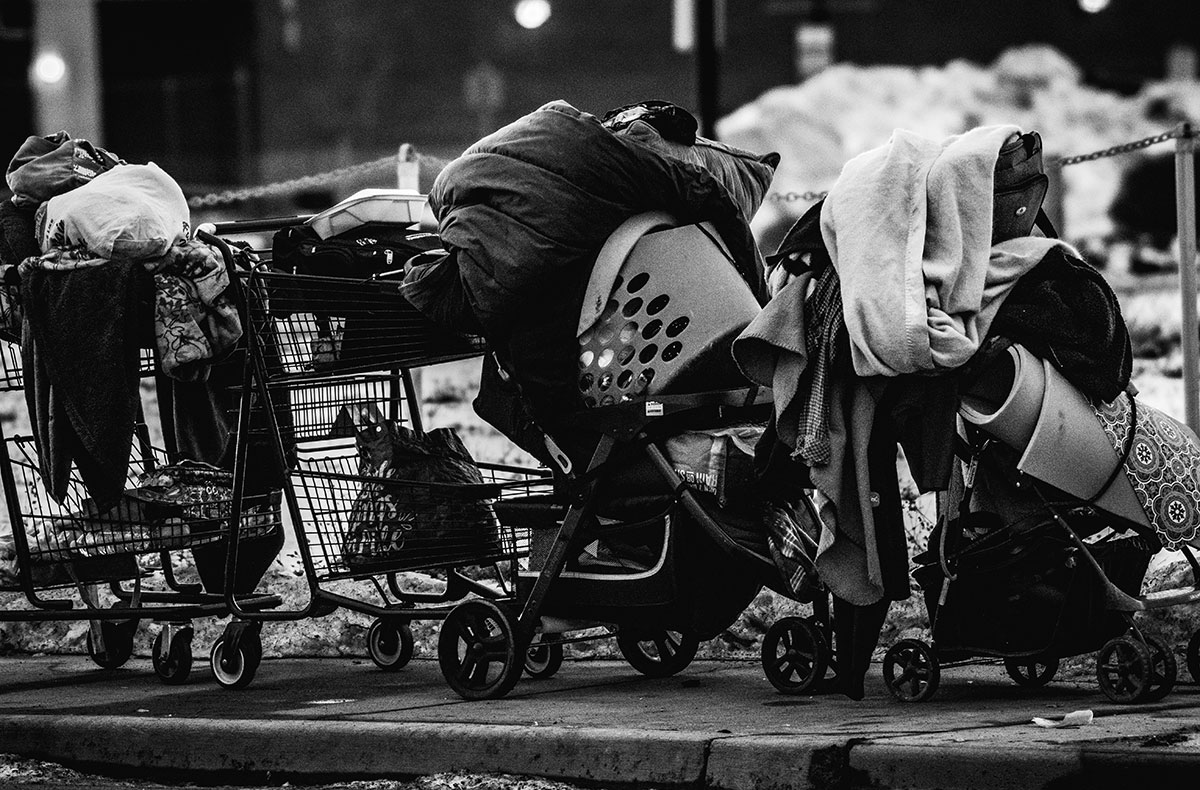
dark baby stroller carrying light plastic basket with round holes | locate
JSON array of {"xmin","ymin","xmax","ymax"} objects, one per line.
[{"xmin": 438, "ymin": 216, "xmax": 829, "ymax": 700}]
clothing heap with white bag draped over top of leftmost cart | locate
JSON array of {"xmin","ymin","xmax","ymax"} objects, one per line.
[{"xmin": 0, "ymin": 132, "xmax": 241, "ymax": 509}]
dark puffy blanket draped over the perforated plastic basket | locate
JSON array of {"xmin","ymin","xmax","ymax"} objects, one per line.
[{"xmin": 406, "ymin": 101, "xmax": 774, "ymax": 458}]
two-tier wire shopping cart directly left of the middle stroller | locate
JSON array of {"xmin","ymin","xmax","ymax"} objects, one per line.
[{"xmin": 198, "ymin": 217, "xmax": 550, "ymax": 688}]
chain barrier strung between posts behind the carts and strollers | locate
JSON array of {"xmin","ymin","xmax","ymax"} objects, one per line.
[{"xmin": 187, "ymin": 125, "xmax": 1190, "ymax": 208}]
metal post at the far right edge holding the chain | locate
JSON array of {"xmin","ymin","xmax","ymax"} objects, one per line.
[{"xmin": 1175, "ymin": 122, "xmax": 1200, "ymax": 432}]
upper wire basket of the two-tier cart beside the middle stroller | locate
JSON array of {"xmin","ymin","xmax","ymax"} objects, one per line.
[{"xmin": 246, "ymin": 269, "xmax": 484, "ymax": 379}]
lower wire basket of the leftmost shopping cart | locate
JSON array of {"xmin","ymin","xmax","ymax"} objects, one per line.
[{"xmin": 0, "ymin": 437, "xmax": 281, "ymax": 587}]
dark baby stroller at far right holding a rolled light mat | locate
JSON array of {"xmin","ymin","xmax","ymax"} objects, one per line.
[{"xmin": 883, "ymin": 340, "xmax": 1200, "ymax": 704}]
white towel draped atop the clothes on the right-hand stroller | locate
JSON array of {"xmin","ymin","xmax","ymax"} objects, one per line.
[{"xmin": 821, "ymin": 125, "xmax": 1062, "ymax": 376}]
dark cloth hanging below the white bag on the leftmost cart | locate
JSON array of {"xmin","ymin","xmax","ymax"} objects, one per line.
[{"xmin": 20, "ymin": 262, "xmax": 145, "ymax": 510}]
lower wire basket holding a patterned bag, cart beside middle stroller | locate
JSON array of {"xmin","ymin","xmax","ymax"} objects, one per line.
[{"xmin": 293, "ymin": 445, "xmax": 540, "ymax": 580}]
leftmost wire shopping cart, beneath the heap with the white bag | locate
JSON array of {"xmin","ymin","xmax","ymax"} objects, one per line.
[{"xmin": 0, "ymin": 340, "xmax": 280, "ymax": 684}]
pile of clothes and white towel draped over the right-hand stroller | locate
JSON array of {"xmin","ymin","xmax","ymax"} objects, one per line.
[{"xmin": 733, "ymin": 125, "xmax": 1132, "ymax": 696}]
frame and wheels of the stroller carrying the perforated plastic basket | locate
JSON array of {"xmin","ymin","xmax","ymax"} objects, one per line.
[{"xmin": 438, "ymin": 387, "xmax": 833, "ymax": 700}]
